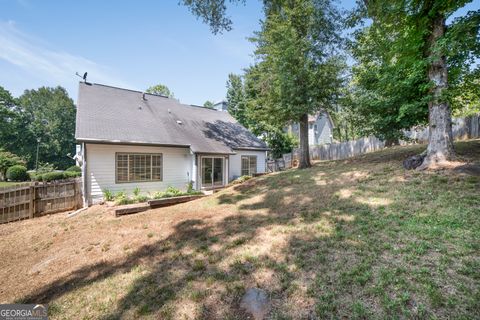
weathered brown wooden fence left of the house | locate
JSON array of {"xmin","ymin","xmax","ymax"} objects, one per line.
[{"xmin": 0, "ymin": 179, "xmax": 82, "ymax": 223}]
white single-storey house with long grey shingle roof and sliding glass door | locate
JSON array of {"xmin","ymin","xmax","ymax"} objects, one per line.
[{"xmin": 75, "ymin": 82, "xmax": 268, "ymax": 204}]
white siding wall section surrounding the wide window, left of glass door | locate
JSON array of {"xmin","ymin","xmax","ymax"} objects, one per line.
[{"xmin": 86, "ymin": 144, "xmax": 194, "ymax": 202}]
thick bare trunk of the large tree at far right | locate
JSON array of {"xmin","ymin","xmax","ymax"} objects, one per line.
[{"xmin": 419, "ymin": 15, "xmax": 455, "ymax": 170}]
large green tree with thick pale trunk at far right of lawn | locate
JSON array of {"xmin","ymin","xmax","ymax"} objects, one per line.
[{"xmin": 352, "ymin": 0, "xmax": 480, "ymax": 169}]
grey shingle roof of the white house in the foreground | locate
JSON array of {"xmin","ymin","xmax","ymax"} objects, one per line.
[{"xmin": 75, "ymin": 82, "xmax": 267, "ymax": 154}]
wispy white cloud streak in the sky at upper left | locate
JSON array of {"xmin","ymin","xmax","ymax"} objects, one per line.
[{"xmin": 0, "ymin": 21, "xmax": 130, "ymax": 98}]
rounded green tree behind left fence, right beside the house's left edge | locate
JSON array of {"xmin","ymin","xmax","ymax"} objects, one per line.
[{"xmin": 15, "ymin": 87, "xmax": 76, "ymax": 169}]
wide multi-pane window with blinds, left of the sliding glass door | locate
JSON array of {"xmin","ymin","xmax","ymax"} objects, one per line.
[{"xmin": 116, "ymin": 153, "xmax": 163, "ymax": 182}]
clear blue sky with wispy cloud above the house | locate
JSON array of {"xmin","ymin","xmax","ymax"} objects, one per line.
[{"xmin": 0, "ymin": 0, "xmax": 480, "ymax": 105}]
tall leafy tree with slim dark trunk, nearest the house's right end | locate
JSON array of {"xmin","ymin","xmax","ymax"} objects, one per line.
[{"xmin": 246, "ymin": 0, "xmax": 344, "ymax": 168}]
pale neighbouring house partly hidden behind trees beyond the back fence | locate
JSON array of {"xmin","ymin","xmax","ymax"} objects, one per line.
[{"xmin": 285, "ymin": 110, "xmax": 335, "ymax": 145}]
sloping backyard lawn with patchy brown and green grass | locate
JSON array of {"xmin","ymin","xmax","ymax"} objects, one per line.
[{"xmin": 0, "ymin": 140, "xmax": 480, "ymax": 319}]
